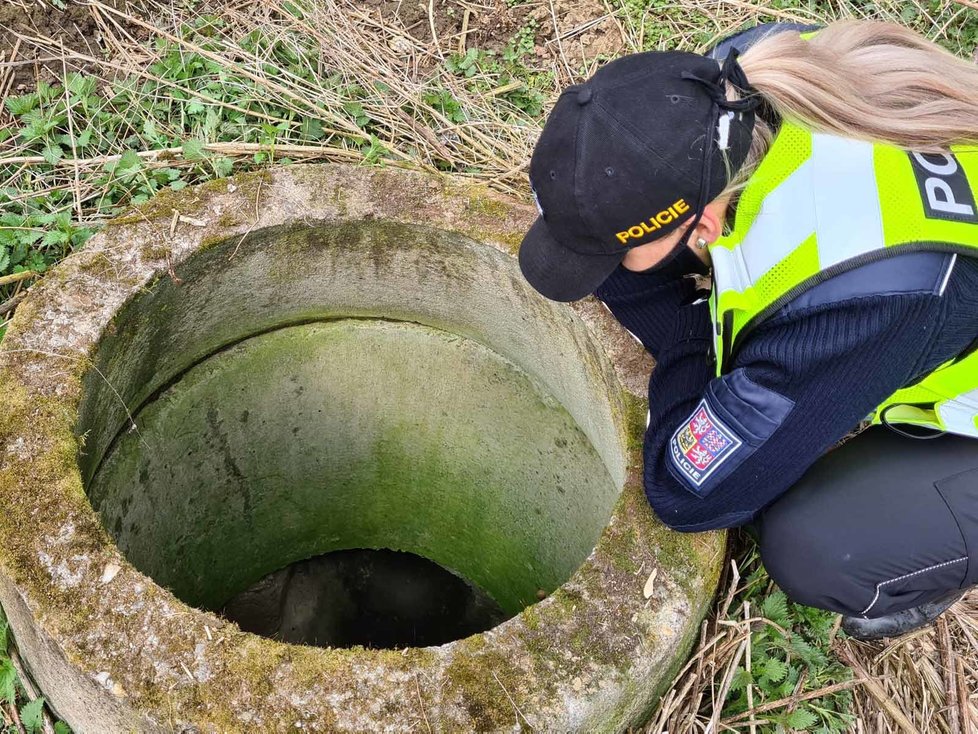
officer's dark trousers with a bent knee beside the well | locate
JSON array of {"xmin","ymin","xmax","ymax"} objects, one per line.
[{"xmin": 757, "ymin": 427, "xmax": 978, "ymax": 618}]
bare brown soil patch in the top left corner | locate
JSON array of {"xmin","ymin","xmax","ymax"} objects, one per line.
[{"xmin": 0, "ymin": 0, "xmax": 146, "ymax": 94}]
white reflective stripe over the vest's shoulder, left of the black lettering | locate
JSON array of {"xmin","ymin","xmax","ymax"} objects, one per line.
[{"xmin": 710, "ymin": 134, "xmax": 885, "ymax": 300}]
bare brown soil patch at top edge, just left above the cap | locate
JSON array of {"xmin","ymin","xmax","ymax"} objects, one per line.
[{"xmin": 363, "ymin": 0, "xmax": 624, "ymax": 73}]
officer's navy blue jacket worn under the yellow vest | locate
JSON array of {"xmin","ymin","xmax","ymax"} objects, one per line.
[{"xmin": 596, "ymin": 249, "xmax": 978, "ymax": 531}]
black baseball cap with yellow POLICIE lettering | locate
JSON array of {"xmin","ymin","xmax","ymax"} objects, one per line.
[{"xmin": 519, "ymin": 51, "xmax": 757, "ymax": 301}]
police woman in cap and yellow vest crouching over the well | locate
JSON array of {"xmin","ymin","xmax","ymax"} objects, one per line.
[{"xmin": 520, "ymin": 21, "xmax": 978, "ymax": 639}]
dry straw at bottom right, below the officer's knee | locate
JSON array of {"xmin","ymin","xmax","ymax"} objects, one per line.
[{"xmin": 642, "ymin": 544, "xmax": 978, "ymax": 734}]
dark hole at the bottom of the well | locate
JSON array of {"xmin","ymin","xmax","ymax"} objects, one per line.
[{"xmin": 221, "ymin": 549, "xmax": 508, "ymax": 648}]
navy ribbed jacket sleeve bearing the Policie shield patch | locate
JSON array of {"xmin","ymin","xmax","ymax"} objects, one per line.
[{"xmin": 644, "ymin": 293, "xmax": 947, "ymax": 531}]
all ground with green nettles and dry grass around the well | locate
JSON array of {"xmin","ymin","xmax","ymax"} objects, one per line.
[{"xmin": 0, "ymin": 0, "xmax": 978, "ymax": 734}]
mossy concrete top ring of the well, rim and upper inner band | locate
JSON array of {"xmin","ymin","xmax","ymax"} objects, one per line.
[{"xmin": 0, "ymin": 166, "xmax": 722, "ymax": 732}]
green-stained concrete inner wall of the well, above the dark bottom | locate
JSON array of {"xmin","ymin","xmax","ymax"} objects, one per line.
[{"xmin": 79, "ymin": 222, "xmax": 624, "ymax": 614}]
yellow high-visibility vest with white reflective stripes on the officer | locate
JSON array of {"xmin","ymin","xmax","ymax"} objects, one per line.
[{"xmin": 710, "ymin": 122, "xmax": 978, "ymax": 437}]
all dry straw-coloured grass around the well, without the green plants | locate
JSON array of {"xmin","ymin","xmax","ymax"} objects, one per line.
[{"xmin": 0, "ymin": 0, "xmax": 978, "ymax": 734}]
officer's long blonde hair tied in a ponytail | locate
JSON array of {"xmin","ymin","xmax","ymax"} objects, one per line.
[{"xmin": 721, "ymin": 20, "xmax": 978, "ymax": 196}]
